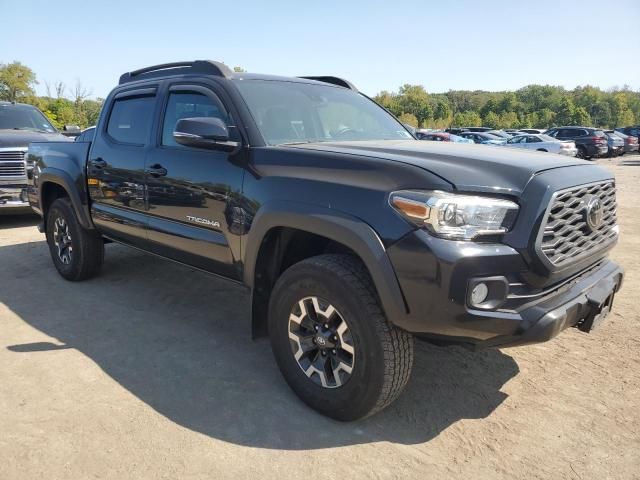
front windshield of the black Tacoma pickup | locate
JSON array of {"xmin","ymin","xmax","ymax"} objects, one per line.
[{"xmin": 236, "ymin": 79, "xmax": 413, "ymax": 145}]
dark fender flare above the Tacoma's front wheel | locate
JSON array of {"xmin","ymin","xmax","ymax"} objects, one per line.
[{"xmin": 243, "ymin": 201, "xmax": 407, "ymax": 323}]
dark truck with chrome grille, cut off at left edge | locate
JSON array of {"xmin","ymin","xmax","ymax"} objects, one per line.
[{"xmin": 0, "ymin": 102, "xmax": 67, "ymax": 214}]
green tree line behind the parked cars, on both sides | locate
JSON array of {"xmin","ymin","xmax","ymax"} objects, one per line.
[{"xmin": 0, "ymin": 62, "xmax": 640, "ymax": 128}]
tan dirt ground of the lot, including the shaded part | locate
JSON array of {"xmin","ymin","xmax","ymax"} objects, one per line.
[{"xmin": 0, "ymin": 156, "xmax": 640, "ymax": 480}]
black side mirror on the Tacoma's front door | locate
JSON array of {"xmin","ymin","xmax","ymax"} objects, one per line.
[{"xmin": 173, "ymin": 117, "xmax": 240, "ymax": 153}]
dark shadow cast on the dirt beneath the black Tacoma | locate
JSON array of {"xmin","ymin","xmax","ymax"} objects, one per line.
[{"xmin": 0, "ymin": 242, "xmax": 519, "ymax": 450}]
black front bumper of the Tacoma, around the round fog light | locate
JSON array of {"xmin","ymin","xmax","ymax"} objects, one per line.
[{"xmin": 388, "ymin": 231, "xmax": 623, "ymax": 349}]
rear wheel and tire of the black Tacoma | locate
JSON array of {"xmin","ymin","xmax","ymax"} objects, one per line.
[{"xmin": 46, "ymin": 198, "xmax": 104, "ymax": 281}]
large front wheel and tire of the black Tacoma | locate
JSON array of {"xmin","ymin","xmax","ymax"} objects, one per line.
[{"xmin": 269, "ymin": 255, "xmax": 413, "ymax": 421}]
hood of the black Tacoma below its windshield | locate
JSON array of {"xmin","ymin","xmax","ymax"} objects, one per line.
[{"xmin": 288, "ymin": 140, "xmax": 599, "ymax": 195}]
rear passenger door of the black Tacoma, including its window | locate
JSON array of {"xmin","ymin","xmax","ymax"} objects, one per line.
[{"xmin": 87, "ymin": 87, "xmax": 157, "ymax": 248}]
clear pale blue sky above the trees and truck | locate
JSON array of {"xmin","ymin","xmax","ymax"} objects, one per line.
[{"xmin": 0, "ymin": 0, "xmax": 640, "ymax": 97}]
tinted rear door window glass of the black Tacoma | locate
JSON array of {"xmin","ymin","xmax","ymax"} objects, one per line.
[{"xmin": 107, "ymin": 97, "xmax": 155, "ymax": 145}]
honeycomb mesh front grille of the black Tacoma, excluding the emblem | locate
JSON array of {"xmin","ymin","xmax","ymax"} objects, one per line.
[{"xmin": 539, "ymin": 181, "xmax": 618, "ymax": 267}]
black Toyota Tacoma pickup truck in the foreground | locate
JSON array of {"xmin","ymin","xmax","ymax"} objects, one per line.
[{"xmin": 28, "ymin": 61, "xmax": 623, "ymax": 420}]
